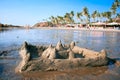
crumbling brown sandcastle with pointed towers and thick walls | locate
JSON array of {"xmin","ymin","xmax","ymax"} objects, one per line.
[{"xmin": 16, "ymin": 41, "xmax": 110, "ymax": 73}]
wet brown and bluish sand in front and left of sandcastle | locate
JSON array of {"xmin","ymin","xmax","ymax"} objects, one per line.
[{"xmin": 0, "ymin": 49, "xmax": 120, "ymax": 80}]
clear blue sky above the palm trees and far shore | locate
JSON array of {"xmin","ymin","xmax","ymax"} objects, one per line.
[{"xmin": 0, "ymin": 0, "xmax": 114, "ymax": 25}]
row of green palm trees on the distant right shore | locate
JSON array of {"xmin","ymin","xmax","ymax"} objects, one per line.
[{"xmin": 46, "ymin": 0, "xmax": 120, "ymax": 25}]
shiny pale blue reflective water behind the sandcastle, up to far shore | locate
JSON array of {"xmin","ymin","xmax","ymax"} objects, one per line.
[{"xmin": 0, "ymin": 29, "xmax": 120, "ymax": 57}]
